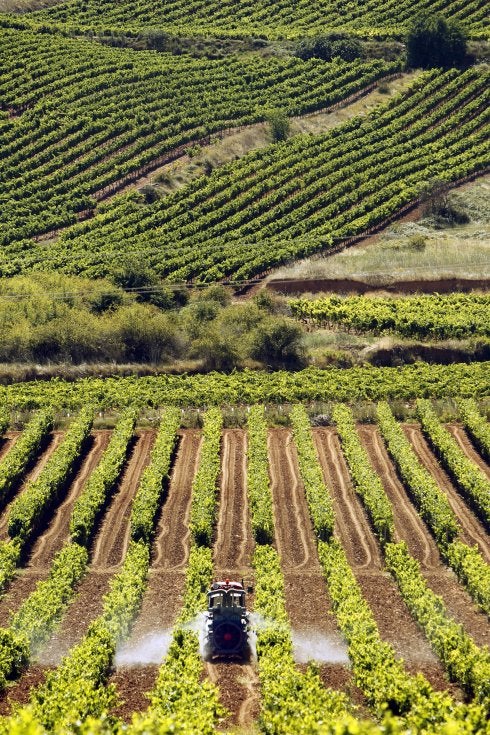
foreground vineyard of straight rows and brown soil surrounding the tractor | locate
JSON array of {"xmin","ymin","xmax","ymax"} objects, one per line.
[{"xmin": 0, "ymin": 400, "xmax": 490, "ymax": 734}]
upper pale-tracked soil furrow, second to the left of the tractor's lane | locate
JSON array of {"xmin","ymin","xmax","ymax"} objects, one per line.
[{"xmin": 92, "ymin": 430, "xmax": 155, "ymax": 572}]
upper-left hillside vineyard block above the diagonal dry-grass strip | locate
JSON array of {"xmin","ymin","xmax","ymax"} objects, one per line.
[{"xmin": 0, "ymin": 28, "xmax": 397, "ymax": 247}]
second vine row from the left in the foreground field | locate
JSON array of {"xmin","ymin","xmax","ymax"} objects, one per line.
[{"xmin": 8, "ymin": 406, "xmax": 94, "ymax": 548}]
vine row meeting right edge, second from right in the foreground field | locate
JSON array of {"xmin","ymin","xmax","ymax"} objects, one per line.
[{"xmin": 417, "ymin": 400, "xmax": 490, "ymax": 529}]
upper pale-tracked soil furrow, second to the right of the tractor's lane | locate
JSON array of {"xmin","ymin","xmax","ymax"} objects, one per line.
[{"xmin": 314, "ymin": 428, "xmax": 382, "ymax": 571}]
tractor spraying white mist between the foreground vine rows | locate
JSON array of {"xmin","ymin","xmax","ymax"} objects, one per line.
[{"xmin": 204, "ymin": 579, "xmax": 251, "ymax": 661}]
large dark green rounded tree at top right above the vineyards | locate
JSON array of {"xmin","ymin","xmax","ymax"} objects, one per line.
[{"xmin": 407, "ymin": 15, "xmax": 466, "ymax": 69}]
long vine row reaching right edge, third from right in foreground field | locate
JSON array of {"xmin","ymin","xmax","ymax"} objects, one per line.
[{"xmin": 377, "ymin": 403, "xmax": 490, "ymax": 614}]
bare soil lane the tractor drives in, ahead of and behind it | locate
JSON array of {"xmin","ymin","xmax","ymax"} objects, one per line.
[{"xmin": 206, "ymin": 429, "xmax": 259, "ymax": 729}]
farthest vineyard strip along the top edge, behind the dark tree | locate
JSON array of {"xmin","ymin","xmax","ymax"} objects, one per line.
[{"xmin": 30, "ymin": 0, "xmax": 488, "ymax": 38}]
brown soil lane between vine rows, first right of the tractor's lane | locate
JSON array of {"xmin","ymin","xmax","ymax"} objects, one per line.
[{"xmin": 268, "ymin": 429, "xmax": 362, "ymax": 703}]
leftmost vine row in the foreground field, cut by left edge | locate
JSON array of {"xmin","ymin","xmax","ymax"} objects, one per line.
[{"xmin": 0, "ymin": 410, "xmax": 53, "ymax": 508}]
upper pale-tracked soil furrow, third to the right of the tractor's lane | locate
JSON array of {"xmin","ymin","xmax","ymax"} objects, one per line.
[{"xmin": 358, "ymin": 424, "xmax": 441, "ymax": 569}]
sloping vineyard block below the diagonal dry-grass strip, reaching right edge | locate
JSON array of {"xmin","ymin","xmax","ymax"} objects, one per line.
[{"xmin": 12, "ymin": 67, "xmax": 490, "ymax": 282}]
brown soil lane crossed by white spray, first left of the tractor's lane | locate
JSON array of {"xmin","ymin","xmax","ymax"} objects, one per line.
[{"xmin": 110, "ymin": 430, "xmax": 201, "ymax": 722}]
